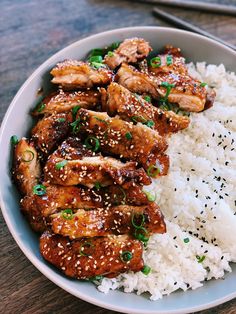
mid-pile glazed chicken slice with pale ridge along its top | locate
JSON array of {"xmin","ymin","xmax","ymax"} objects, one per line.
[{"xmin": 44, "ymin": 137, "xmax": 151, "ymax": 188}]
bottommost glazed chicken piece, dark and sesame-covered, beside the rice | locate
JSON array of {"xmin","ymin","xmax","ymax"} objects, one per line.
[{"xmin": 40, "ymin": 232, "xmax": 144, "ymax": 279}]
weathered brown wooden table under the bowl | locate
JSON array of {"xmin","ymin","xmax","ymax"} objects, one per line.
[{"xmin": 0, "ymin": 0, "xmax": 236, "ymax": 314}]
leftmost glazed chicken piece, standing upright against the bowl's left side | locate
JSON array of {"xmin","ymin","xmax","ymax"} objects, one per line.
[{"xmin": 12, "ymin": 138, "xmax": 41, "ymax": 195}]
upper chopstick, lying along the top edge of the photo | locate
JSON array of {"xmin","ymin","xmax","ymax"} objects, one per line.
[{"xmin": 135, "ymin": 0, "xmax": 236, "ymax": 16}]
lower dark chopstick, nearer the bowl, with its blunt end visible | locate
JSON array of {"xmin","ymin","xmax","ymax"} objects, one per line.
[{"xmin": 153, "ymin": 8, "xmax": 236, "ymax": 50}]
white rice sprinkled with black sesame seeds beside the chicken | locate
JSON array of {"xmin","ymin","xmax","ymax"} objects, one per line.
[{"xmin": 98, "ymin": 63, "xmax": 236, "ymax": 300}]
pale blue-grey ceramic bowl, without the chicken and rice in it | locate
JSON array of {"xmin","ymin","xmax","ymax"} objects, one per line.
[{"xmin": 0, "ymin": 27, "xmax": 236, "ymax": 314}]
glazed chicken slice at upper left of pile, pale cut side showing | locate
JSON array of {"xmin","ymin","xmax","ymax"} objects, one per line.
[{"xmin": 51, "ymin": 60, "xmax": 113, "ymax": 90}]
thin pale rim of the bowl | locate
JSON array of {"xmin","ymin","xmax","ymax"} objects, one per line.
[{"xmin": 0, "ymin": 26, "xmax": 236, "ymax": 314}]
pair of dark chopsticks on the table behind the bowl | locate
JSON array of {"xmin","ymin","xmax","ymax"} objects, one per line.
[{"xmin": 135, "ymin": 0, "xmax": 236, "ymax": 50}]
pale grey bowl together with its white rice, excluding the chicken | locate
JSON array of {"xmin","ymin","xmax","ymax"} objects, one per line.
[{"xmin": 0, "ymin": 27, "xmax": 236, "ymax": 314}]
